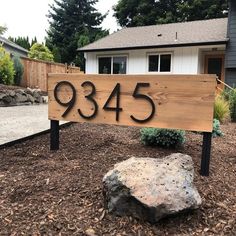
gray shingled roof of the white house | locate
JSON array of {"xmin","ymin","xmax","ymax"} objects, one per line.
[{"xmin": 78, "ymin": 18, "xmax": 228, "ymax": 52}]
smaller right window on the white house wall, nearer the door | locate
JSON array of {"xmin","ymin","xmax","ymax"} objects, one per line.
[{"xmin": 148, "ymin": 54, "xmax": 171, "ymax": 72}]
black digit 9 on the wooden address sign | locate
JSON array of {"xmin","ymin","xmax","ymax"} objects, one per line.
[{"xmin": 54, "ymin": 81, "xmax": 76, "ymax": 117}]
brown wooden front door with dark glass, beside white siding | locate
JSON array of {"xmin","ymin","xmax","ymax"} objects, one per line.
[{"xmin": 205, "ymin": 54, "xmax": 225, "ymax": 90}]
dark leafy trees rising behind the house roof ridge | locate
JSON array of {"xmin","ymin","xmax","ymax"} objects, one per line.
[{"xmin": 113, "ymin": 0, "xmax": 228, "ymax": 27}]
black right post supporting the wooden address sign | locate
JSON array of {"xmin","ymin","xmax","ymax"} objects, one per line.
[{"xmin": 200, "ymin": 132, "xmax": 212, "ymax": 176}]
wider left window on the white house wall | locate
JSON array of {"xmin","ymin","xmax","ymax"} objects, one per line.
[{"xmin": 98, "ymin": 56, "xmax": 127, "ymax": 74}]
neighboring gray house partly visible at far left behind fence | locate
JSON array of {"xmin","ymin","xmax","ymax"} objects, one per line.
[{"xmin": 0, "ymin": 36, "xmax": 29, "ymax": 57}]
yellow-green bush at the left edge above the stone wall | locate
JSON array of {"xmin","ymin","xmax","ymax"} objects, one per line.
[{"xmin": 0, "ymin": 45, "xmax": 15, "ymax": 85}]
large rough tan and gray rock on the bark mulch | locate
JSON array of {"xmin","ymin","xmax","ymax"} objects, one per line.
[{"xmin": 103, "ymin": 153, "xmax": 201, "ymax": 223}]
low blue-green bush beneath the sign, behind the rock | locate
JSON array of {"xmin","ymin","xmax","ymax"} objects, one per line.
[{"xmin": 140, "ymin": 128, "xmax": 185, "ymax": 148}]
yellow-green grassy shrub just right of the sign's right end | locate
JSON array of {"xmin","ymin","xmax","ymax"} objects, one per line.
[{"xmin": 214, "ymin": 96, "xmax": 229, "ymax": 122}]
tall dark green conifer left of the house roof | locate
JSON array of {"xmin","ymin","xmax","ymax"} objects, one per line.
[{"xmin": 46, "ymin": 0, "xmax": 108, "ymax": 66}]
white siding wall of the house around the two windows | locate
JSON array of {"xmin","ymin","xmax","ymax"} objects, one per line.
[{"xmin": 85, "ymin": 46, "xmax": 225, "ymax": 74}]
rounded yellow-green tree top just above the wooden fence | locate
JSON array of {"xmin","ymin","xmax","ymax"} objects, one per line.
[{"xmin": 28, "ymin": 43, "xmax": 53, "ymax": 61}]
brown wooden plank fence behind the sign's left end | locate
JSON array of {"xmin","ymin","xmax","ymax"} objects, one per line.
[{"xmin": 21, "ymin": 57, "xmax": 83, "ymax": 92}]
